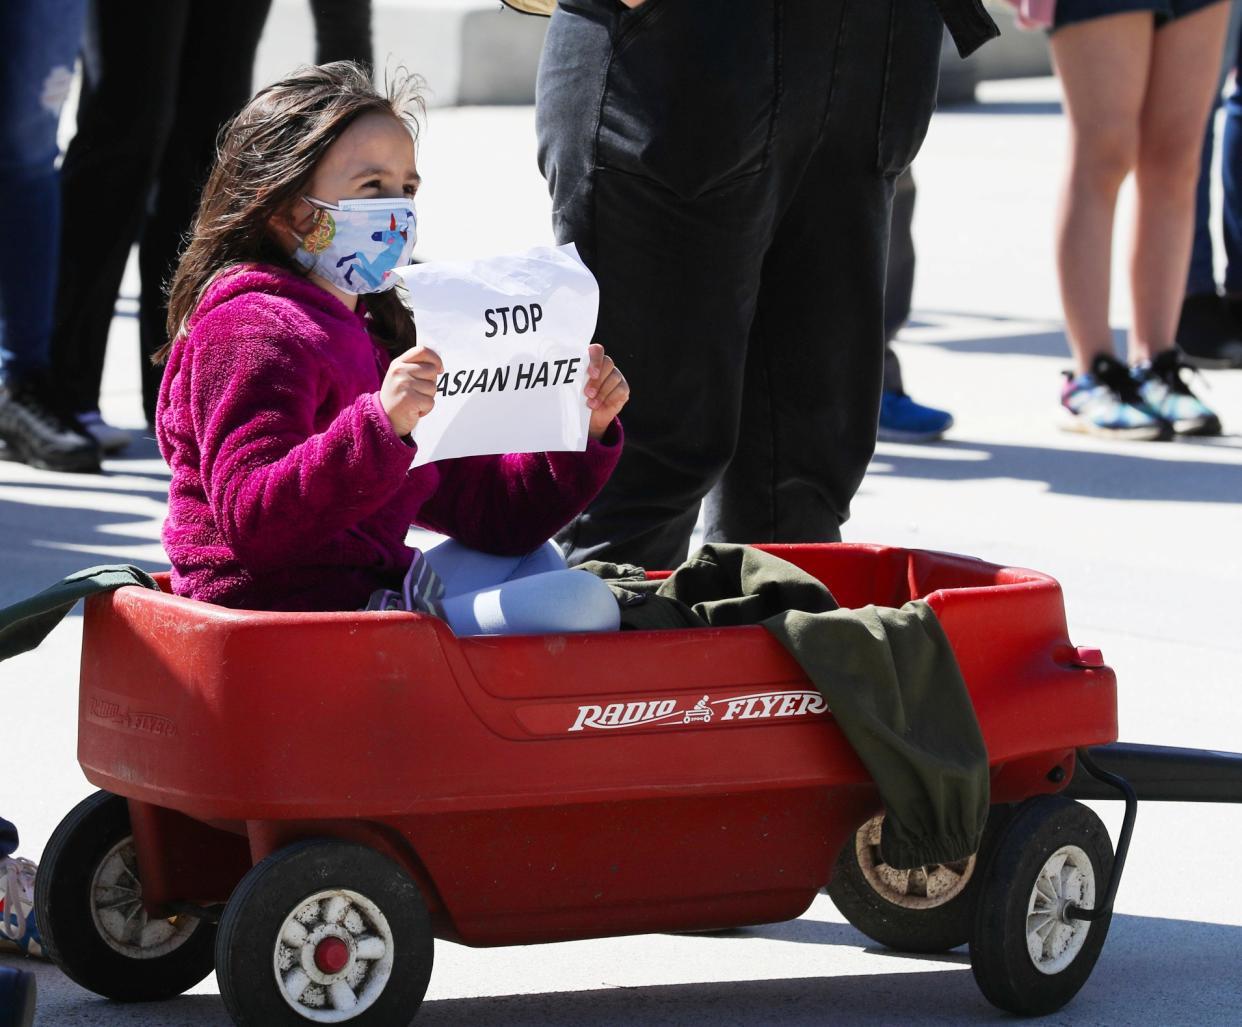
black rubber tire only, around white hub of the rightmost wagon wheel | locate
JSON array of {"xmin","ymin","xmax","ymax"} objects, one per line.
[{"xmin": 970, "ymin": 796, "xmax": 1113, "ymax": 1016}]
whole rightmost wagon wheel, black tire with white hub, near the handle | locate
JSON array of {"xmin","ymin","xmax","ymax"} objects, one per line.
[{"xmin": 970, "ymin": 796, "xmax": 1113, "ymax": 1016}]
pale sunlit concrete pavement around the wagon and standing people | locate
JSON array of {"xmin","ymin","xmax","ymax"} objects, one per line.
[{"xmin": 0, "ymin": 79, "xmax": 1242, "ymax": 1027}]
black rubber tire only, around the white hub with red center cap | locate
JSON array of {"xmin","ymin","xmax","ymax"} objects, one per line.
[{"xmin": 216, "ymin": 838, "xmax": 433, "ymax": 1027}]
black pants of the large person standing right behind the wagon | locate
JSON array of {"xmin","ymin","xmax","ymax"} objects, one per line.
[{"xmin": 537, "ymin": 0, "xmax": 944, "ymax": 568}]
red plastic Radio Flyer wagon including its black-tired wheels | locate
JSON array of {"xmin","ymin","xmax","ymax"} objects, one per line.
[{"xmin": 36, "ymin": 545, "xmax": 1133, "ymax": 1027}]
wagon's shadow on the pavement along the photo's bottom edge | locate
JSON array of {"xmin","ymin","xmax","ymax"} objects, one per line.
[{"xmin": 12, "ymin": 915, "xmax": 1242, "ymax": 1027}]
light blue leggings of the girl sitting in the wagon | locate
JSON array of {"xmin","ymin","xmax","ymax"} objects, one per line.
[{"xmin": 425, "ymin": 539, "xmax": 621, "ymax": 635}]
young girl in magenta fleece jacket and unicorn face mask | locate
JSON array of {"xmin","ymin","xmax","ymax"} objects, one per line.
[{"xmin": 155, "ymin": 62, "xmax": 630, "ymax": 633}]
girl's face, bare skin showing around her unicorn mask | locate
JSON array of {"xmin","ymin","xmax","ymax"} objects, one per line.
[{"xmin": 273, "ymin": 111, "xmax": 421, "ymax": 308}]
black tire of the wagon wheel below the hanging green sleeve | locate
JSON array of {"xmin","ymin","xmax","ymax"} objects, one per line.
[{"xmin": 825, "ymin": 806, "xmax": 1011, "ymax": 952}]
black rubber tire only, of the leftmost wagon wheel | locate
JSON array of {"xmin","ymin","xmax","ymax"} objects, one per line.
[{"xmin": 35, "ymin": 791, "xmax": 215, "ymax": 1002}]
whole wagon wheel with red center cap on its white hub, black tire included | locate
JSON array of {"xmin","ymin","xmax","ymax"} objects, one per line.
[{"xmin": 216, "ymin": 839, "xmax": 432, "ymax": 1027}]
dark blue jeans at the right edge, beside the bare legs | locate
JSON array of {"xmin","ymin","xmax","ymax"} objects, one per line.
[{"xmin": 1186, "ymin": 0, "xmax": 1242, "ymax": 296}]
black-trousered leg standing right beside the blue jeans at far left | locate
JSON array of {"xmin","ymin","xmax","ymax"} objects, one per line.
[{"xmin": 52, "ymin": 0, "xmax": 190, "ymax": 422}]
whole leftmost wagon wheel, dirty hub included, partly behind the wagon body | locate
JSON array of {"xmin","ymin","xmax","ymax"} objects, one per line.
[{"xmin": 35, "ymin": 791, "xmax": 216, "ymax": 1002}]
